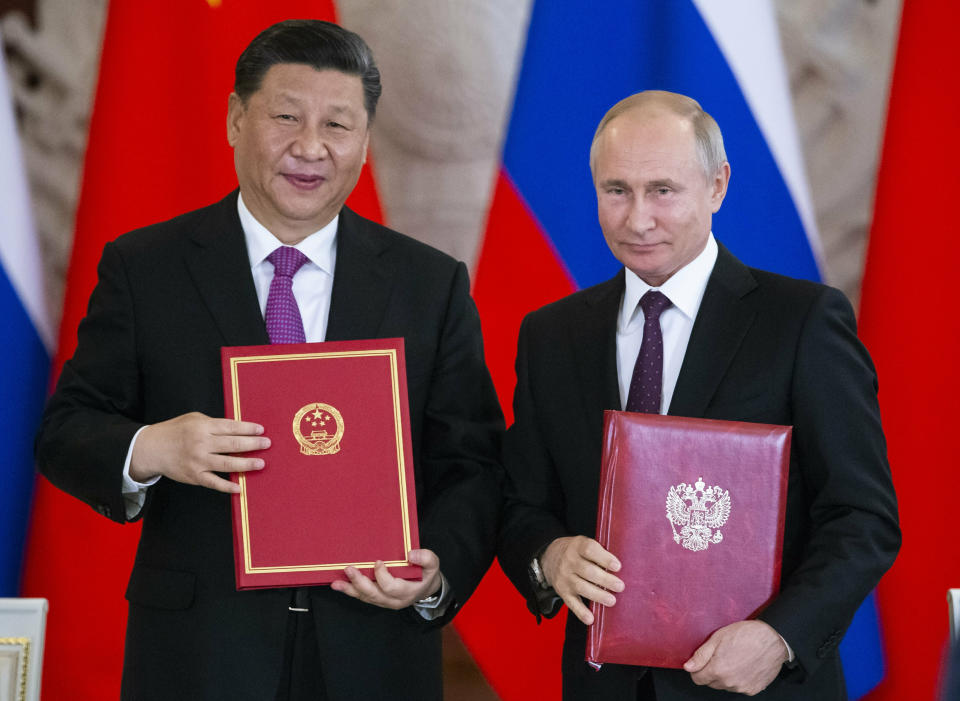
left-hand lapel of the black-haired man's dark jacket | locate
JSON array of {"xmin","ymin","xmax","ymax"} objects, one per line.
[{"xmin": 186, "ymin": 191, "xmax": 270, "ymax": 346}]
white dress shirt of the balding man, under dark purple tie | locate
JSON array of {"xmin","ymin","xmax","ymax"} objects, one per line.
[{"xmin": 617, "ymin": 233, "xmax": 717, "ymax": 414}]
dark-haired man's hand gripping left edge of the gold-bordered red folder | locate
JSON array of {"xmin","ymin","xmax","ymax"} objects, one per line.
[{"xmin": 130, "ymin": 412, "xmax": 270, "ymax": 494}]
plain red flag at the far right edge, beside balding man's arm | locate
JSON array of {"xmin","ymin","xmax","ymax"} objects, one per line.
[{"xmin": 850, "ymin": 0, "xmax": 960, "ymax": 701}]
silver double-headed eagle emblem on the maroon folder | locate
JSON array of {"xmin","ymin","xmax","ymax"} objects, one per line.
[{"xmin": 667, "ymin": 477, "xmax": 730, "ymax": 552}]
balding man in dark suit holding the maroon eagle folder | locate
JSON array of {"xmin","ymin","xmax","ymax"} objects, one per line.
[{"xmin": 499, "ymin": 91, "xmax": 900, "ymax": 701}]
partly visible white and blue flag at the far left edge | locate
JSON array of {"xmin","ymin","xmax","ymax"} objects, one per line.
[{"xmin": 0, "ymin": 35, "xmax": 53, "ymax": 596}]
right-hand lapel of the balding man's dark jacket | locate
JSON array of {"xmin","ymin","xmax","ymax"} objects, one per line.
[{"xmin": 668, "ymin": 245, "xmax": 757, "ymax": 417}]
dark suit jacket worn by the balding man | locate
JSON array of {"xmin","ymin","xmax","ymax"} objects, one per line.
[{"xmin": 499, "ymin": 246, "xmax": 900, "ymax": 701}]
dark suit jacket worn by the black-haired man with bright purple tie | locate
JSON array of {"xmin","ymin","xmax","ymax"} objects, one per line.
[{"xmin": 37, "ymin": 193, "xmax": 503, "ymax": 701}]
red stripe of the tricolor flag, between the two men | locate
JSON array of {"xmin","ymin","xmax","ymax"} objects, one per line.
[{"xmin": 454, "ymin": 172, "xmax": 575, "ymax": 701}]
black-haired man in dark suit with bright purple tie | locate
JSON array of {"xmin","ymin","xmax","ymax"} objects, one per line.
[{"xmin": 37, "ymin": 21, "xmax": 503, "ymax": 701}]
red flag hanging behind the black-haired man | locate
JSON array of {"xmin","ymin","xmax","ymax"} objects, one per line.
[{"xmin": 17, "ymin": 0, "xmax": 380, "ymax": 701}]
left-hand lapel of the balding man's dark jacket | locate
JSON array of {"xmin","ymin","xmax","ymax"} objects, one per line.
[{"xmin": 570, "ymin": 269, "xmax": 624, "ymax": 438}]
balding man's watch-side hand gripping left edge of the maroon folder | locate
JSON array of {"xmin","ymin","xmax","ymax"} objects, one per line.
[{"xmin": 540, "ymin": 535, "xmax": 623, "ymax": 625}]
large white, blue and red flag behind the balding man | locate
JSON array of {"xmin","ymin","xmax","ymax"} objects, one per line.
[{"xmin": 459, "ymin": 0, "xmax": 883, "ymax": 699}]
